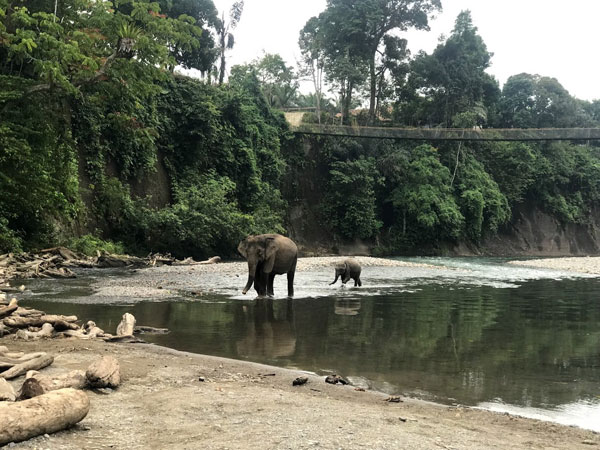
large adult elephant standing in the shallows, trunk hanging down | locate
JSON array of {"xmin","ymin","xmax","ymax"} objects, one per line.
[{"xmin": 238, "ymin": 234, "xmax": 298, "ymax": 297}]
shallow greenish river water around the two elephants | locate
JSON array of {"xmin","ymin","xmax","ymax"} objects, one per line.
[{"xmin": 16, "ymin": 258, "xmax": 600, "ymax": 431}]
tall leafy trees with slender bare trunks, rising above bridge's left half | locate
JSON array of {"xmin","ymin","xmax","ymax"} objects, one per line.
[{"xmin": 300, "ymin": 0, "xmax": 441, "ymax": 123}]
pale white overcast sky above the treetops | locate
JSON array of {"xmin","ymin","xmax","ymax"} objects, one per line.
[{"xmin": 213, "ymin": 0, "xmax": 600, "ymax": 100}]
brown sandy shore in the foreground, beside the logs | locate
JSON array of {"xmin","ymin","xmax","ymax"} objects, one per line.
[{"xmin": 0, "ymin": 338, "xmax": 600, "ymax": 450}]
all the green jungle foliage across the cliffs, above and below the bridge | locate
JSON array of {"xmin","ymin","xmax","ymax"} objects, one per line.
[{"xmin": 0, "ymin": 0, "xmax": 600, "ymax": 257}]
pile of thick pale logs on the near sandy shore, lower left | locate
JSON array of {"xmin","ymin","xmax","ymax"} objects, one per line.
[{"xmin": 0, "ymin": 346, "xmax": 121, "ymax": 446}]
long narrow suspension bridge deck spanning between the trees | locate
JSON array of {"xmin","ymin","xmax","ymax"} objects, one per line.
[{"xmin": 290, "ymin": 124, "xmax": 600, "ymax": 141}]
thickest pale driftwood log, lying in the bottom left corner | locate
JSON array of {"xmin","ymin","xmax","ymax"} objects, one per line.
[{"xmin": 0, "ymin": 389, "xmax": 90, "ymax": 445}]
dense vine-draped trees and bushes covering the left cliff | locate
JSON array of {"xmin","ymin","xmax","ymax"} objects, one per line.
[{"xmin": 0, "ymin": 0, "xmax": 286, "ymax": 256}]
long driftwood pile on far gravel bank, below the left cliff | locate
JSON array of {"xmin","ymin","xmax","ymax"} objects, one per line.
[{"xmin": 0, "ymin": 247, "xmax": 221, "ymax": 284}]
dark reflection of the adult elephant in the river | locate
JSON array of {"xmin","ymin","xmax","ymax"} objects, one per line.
[{"xmin": 236, "ymin": 297, "xmax": 296, "ymax": 358}]
